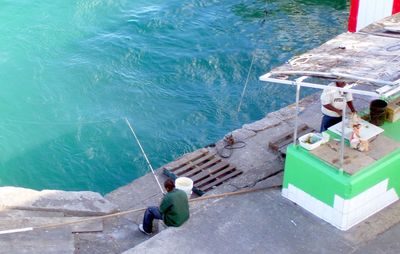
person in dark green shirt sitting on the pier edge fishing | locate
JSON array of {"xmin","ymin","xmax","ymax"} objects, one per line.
[{"xmin": 139, "ymin": 179, "xmax": 189, "ymax": 235}]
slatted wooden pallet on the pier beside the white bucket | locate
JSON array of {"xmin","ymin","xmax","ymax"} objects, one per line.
[{"xmin": 163, "ymin": 151, "xmax": 242, "ymax": 196}]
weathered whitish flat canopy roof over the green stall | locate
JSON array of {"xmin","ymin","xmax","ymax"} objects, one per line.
[{"xmin": 260, "ymin": 13, "xmax": 400, "ymax": 97}]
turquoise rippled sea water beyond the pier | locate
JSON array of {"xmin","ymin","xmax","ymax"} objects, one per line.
[{"xmin": 0, "ymin": 0, "xmax": 348, "ymax": 193}]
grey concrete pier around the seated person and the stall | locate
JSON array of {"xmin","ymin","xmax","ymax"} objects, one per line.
[{"xmin": 0, "ymin": 89, "xmax": 400, "ymax": 254}]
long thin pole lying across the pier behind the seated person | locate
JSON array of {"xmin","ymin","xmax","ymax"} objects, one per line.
[{"xmin": 0, "ymin": 185, "xmax": 282, "ymax": 235}]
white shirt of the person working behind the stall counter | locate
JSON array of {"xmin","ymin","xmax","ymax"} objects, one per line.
[{"xmin": 321, "ymin": 83, "xmax": 353, "ymax": 117}]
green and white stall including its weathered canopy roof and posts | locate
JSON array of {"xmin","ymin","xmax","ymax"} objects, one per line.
[{"xmin": 260, "ymin": 16, "xmax": 400, "ymax": 230}]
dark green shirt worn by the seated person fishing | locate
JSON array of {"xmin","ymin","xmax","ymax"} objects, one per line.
[{"xmin": 160, "ymin": 189, "xmax": 189, "ymax": 227}]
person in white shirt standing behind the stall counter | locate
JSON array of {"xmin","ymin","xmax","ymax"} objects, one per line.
[{"xmin": 320, "ymin": 81, "xmax": 356, "ymax": 132}]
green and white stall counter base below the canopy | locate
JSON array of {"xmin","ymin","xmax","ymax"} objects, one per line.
[{"xmin": 282, "ymin": 121, "xmax": 400, "ymax": 230}]
